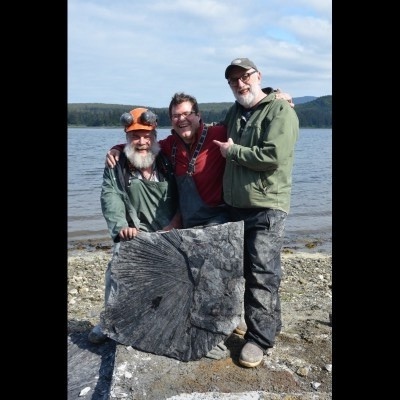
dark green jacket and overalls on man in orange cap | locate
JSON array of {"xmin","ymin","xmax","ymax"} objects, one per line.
[{"xmin": 100, "ymin": 152, "xmax": 178, "ymax": 243}]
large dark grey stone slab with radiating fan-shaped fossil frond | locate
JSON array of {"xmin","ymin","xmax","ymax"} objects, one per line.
[{"xmin": 102, "ymin": 221, "xmax": 244, "ymax": 361}]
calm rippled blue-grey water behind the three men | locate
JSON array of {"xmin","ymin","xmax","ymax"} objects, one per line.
[{"xmin": 68, "ymin": 128, "xmax": 332, "ymax": 252}]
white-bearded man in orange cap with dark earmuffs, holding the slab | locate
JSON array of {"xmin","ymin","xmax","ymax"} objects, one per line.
[{"xmin": 88, "ymin": 107, "xmax": 181, "ymax": 343}]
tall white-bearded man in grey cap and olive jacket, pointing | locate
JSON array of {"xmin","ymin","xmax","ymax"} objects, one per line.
[{"xmin": 214, "ymin": 58, "xmax": 299, "ymax": 367}]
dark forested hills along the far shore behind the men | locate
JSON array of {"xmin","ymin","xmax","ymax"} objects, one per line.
[{"xmin": 67, "ymin": 95, "xmax": 332, "ymax": 128}]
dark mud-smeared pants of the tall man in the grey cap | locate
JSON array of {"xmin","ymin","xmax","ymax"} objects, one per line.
[{"xmin": 228, "ymin": 207, "xmax": 287, "ymax": 350}]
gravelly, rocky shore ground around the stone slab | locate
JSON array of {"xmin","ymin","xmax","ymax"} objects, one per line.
[{"xmin": 68, "ymin": 243, "xmax": 332, "ymax": 400}]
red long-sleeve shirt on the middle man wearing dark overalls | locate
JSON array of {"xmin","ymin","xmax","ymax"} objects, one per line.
[{"xmin": 112, "ymin": 124, "xmax": 227, "ymax": 207}]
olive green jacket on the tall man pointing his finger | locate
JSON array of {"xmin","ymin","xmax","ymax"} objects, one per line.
[{"xmin": 223, "ymin": 93, "xmax": 299, "ymax": 213}]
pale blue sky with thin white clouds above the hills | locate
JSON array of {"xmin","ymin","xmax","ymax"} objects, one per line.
[{"xmin": 67, "ymin": 0, "xmax": 332, "ymax": 108}]
